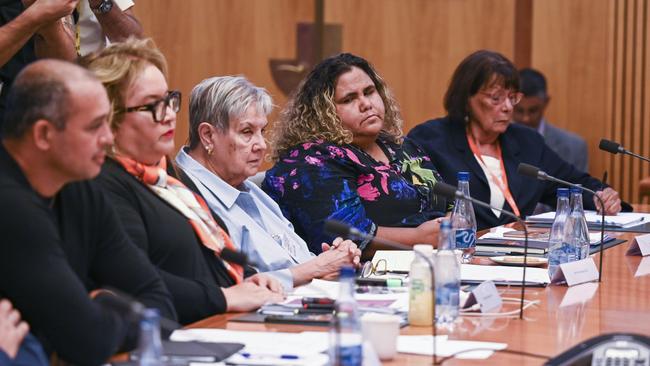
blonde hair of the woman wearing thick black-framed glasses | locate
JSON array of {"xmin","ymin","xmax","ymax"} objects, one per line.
[{"xmin": 79, "ymin": 37, "xmax": 167, "ymax": 131}]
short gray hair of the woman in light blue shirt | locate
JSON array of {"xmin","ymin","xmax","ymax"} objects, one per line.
[{"xmin": 189, "ymin": 76, "xmax": 273, "ymax": 149}]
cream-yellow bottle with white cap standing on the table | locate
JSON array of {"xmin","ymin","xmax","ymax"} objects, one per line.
[{"xmin": 409, "ymin": 244, "xmax": 433, "ymax": 327}]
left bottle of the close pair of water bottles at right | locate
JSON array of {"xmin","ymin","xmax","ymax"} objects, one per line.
[{"xmin": 548, "ymin": 188, "xmax": 575, "ymax": 278}]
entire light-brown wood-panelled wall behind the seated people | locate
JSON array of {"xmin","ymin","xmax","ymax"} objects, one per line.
[{"xmin": 135, "ymin": 0, "xmax": 650, "ymax": 200}]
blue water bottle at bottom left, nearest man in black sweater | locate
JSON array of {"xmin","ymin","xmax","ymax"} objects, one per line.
[{"xmin": 137, "ymin": 309, "xmax": 164, "ymax": 366}]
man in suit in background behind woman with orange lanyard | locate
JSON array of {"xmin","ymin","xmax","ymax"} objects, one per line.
[{"xmin": 512, "ymin": 69, "xmax": 589, "ymax": 172}]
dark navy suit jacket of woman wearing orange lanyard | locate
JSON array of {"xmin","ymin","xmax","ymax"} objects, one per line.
[{"xmin": 408, "ymin": 117, "xmax": 629, "ymax": 230}]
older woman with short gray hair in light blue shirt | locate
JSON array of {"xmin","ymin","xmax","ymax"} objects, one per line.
[{"xmin": 176, "ymin": 76, "xmax": 361, "ymax": 288}]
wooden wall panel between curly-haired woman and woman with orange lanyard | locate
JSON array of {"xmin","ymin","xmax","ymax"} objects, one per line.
[{"xmin": 325, "ymin": 0, "xmax": 515, "ymax": 131}]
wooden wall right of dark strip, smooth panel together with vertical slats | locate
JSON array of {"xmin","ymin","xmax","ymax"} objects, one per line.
[{"xmin": 532, "ymin": 0, "xmax": 650, "ymax": 202}]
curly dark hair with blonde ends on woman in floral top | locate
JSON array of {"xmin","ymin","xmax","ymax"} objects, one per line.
[{"xmin": 270, "ymin": 53, "xmax": 403, "ymax": 160}]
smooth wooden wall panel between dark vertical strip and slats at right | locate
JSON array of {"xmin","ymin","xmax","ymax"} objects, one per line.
[{"xmin": 532, "ymin": 0, "xmax": 611, "ymax": 176}]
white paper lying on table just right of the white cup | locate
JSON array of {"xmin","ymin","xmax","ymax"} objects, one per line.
[{"xmin": 397, "ymin": 335, "xmax": 508, "ymax": 360}]
